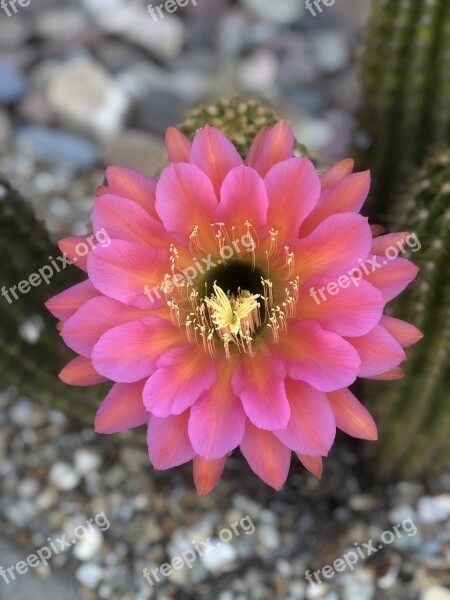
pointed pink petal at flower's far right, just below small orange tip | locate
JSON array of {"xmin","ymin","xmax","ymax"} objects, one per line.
[{"xmin": 364, "ymin": 258, "xmax": 419, "ymax": 302}]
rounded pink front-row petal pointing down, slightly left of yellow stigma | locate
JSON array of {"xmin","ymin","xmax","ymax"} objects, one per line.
[{"xmin": 188, "ymin": 367, "xmax": 246, "ymax": 458}]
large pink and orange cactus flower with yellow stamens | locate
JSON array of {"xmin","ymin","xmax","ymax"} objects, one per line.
[{"xmin": 47, "ymin": 121, "xmax": 421, "ymax": 494}]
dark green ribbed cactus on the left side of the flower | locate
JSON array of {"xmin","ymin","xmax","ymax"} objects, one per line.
[{"xmin": 0, "ymin": 180, "xmax": 104, "ymax": 422}]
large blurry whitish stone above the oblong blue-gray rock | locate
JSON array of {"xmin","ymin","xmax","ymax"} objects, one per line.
[{"xmin": 48, "ymin": 59, "xmax": 129, "ymax": 139}]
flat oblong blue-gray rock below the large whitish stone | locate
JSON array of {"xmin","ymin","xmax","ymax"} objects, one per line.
[{"xmin": 15, "ymin": 125, "xmax": 99, "ymax": 170}]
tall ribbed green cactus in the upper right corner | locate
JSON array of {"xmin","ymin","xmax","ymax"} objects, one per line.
[{"xmin": 357, "ymin": 0, "xmax": 450, "ymax": 219}]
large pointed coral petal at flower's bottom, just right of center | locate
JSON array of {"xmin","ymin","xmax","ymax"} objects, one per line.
[{"xmin": 240, "ymin": 421, "xmax": 291, "ymax": 490}]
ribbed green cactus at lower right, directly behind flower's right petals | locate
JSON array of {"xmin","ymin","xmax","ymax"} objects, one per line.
[{"xmin": 367, "ymin": 150, "xmax": 450, "ymax": 474}]
